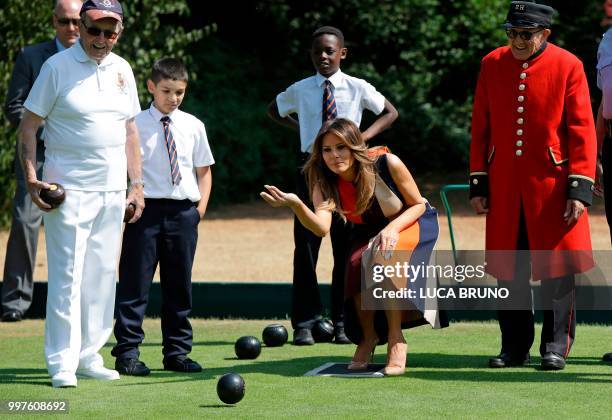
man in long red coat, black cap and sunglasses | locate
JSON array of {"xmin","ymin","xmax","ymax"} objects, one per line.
[{"xmin": 470, "ymin": 1, "xmax": 596, "ymax": 370}]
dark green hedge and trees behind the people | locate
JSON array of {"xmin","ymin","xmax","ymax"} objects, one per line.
[{"xmin": 0, "ymin": 0, "xmax": 603, "ymax": 226}]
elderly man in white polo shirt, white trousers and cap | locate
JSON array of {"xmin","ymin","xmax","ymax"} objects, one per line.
[{"xmin": 18, "ymin": 0, "xmax": 144, "ymax": 387}]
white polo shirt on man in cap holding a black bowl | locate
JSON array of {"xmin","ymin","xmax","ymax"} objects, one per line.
[{"xmin": 24, "ymin": 42, "xmax": 140, "ymax": 191}]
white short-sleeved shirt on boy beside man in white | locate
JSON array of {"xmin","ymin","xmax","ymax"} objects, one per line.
[{"xmin": 136, "ymin": 104, "xmax": 215, "ymax": 202}]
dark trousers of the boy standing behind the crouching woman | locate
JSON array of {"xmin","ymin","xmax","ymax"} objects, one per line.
[{"xmin": 291, "ymin": 154, "xmax": 348, "ymax": 329}]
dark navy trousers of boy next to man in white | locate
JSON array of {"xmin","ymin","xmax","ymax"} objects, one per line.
[{"xmin": 111, "ymin": 199, "xmax": 200, "ymax": 358}]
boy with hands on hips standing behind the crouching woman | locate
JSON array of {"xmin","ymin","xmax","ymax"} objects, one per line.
[{"xmin": 268, "ymin": 26, "xmax": 398, "ymax": 345}]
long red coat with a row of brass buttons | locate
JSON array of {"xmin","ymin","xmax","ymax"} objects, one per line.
[{"xmin": 470, "ymin": 43, "xmax": 596, "ymax": 279}]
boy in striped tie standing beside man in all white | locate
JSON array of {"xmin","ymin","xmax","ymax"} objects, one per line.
[{"xmin": 112, "ymin": 58, "xmax": 214, "ymax": 376}]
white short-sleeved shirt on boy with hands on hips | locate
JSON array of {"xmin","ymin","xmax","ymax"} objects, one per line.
[{"xmin": 276, "ymin": 70, "xmax": 385, "ymax": 152}]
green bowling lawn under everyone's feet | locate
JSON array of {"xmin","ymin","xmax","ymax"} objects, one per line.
[{"xmin": 0, "ymin": 320, "xmax": 612, "ymax": 419}]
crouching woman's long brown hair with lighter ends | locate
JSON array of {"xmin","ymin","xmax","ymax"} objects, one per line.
[{"xmin": 303, "ymin": 118, "xmax": 376, "ymax": 219}]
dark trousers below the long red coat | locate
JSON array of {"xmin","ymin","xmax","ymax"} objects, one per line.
[{"xmin": 498, "ymin": 210, "xmax": 576, "ymax": 358}]
